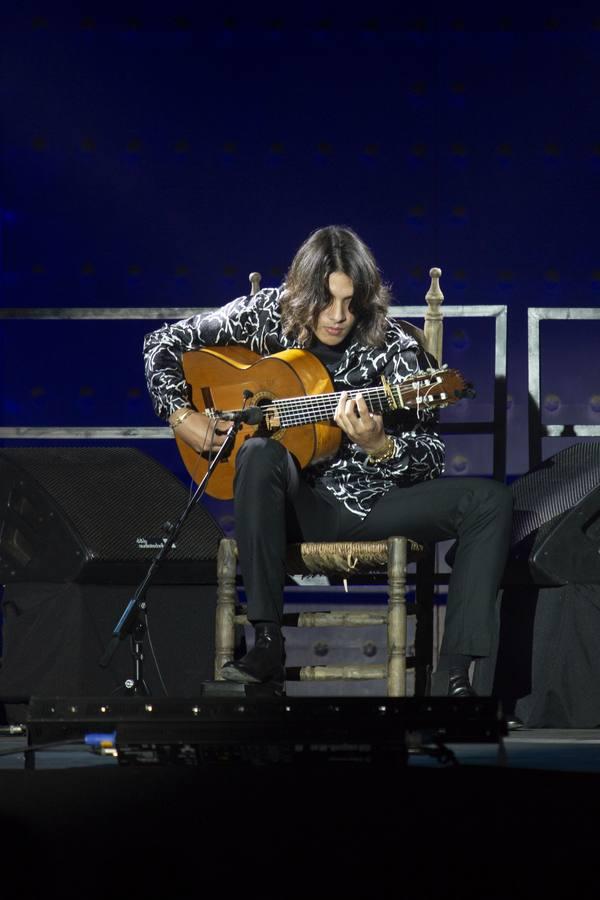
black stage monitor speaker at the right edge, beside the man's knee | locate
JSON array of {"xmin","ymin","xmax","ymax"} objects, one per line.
[{"xmin": 504, "ymin": 441, "xmax": 600, "ymax": 585}]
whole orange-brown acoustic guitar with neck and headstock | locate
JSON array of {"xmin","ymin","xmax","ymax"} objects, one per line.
[{"xmin": 175, "ymin": 345, "xmax": 472, "ymax": 500}]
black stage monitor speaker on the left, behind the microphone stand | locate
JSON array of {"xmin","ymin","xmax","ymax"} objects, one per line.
[{"xmin": 0, "ymin": 447, "xmax": 223, "ymax": 584}]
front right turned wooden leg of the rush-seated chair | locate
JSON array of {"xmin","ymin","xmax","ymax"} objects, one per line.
[{"xmin": 388, "ymin": 537, "xmax": 407, "ymax": 697}]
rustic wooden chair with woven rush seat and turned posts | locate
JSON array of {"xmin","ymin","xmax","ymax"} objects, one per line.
[{"xmin": 215, "ymin": 268, "xmax": 444, "ymax": 697}]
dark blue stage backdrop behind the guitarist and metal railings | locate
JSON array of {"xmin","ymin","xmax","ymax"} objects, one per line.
[{"xmin": 0, "ymin": 2, "xmax": 600, "ymax": 514}]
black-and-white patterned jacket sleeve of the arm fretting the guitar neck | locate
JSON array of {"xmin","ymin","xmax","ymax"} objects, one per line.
[{"xmin": 370, "ymin": 350, "xmax": 445, "ymax": 484}]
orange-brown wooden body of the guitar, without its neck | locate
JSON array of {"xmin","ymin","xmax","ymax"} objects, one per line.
[{"xmin": 175, "ymin": 345, "xmax": 342, "ymax": 500}]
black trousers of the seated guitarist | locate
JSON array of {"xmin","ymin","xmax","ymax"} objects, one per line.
[{"xmin": 234, "ymin": 438, "xmax": 512, "ymax": 657}]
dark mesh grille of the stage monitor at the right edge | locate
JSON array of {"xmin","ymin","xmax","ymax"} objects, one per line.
[{"xmin": 511, "ymin": 441, "xmax": 600, "ymax": 545}]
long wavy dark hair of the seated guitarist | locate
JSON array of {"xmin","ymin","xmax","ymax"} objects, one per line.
[{"xmin": 281, "ymin": 225, "xmax": 390, "ymax": 347}]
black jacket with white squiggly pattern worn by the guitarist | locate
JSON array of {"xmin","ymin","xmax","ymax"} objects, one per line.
[{"xmin": 144, "ymin": 287, "xmax": 444, "ymax": 517}]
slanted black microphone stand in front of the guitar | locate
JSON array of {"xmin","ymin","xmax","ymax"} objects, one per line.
[{"xmin": 99, "ymin": 407, "xmax": 250, "ymax": 697}]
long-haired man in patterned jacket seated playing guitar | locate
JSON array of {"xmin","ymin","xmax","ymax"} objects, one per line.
[{"xmin": 144, "ymin": 226, "xmax": 512, "ymax": 696}]
